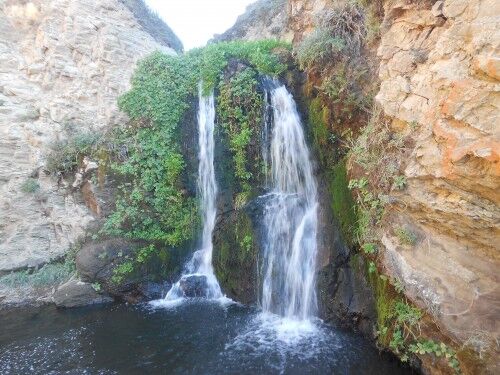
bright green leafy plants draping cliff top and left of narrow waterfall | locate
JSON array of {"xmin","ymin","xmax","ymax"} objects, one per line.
[{"xmin": 104, "ymin": 41, "xmax": 286, "ymax": 253}]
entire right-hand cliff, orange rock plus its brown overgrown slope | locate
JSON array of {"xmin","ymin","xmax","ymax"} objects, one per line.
[{"xmin": 217, "ymin": 0, "xmax": 500, "ymax": 373}]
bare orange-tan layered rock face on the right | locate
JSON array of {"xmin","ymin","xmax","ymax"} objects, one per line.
[{"xmin": 376, "ymin": 0, "xmax": 500, "ymax": 356}]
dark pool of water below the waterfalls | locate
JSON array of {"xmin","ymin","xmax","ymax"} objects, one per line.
[{"xmin": 0, "ymin": 300, "xmax": 410, "ymax": 375}]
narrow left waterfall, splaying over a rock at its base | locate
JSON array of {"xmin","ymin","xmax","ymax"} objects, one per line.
[{"xmin": 165, "ymin": 84, "xmax": 222, "ymax": 300}]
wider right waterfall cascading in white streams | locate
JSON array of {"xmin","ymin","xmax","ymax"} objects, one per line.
[{"xmin": 261, "ymin": 85, "xmax": 318, "ymax": 320}]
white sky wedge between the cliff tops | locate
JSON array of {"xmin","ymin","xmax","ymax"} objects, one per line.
[{"xmin": 146, "ymin": 0, "xmax": 255, "ymax": 51}]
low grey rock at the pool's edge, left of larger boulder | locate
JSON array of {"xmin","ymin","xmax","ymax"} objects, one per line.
[{"xmin": 53, "ymin": 280, "xmax": 113, "ymax": 307}]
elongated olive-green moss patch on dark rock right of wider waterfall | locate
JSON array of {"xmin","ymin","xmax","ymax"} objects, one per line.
[{"xmin": 328, "ymin": 159, "xmax": 358, "ymax": 246}]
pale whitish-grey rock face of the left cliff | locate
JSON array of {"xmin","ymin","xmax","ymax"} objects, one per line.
[{"xmin": 0, "ymin": 0, "xmax": 175, "ymax": 273}]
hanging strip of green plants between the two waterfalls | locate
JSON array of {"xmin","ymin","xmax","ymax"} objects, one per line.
[{"xmin": 217, "ymin": 68, "xmax": 263, "ymax": 203}]
